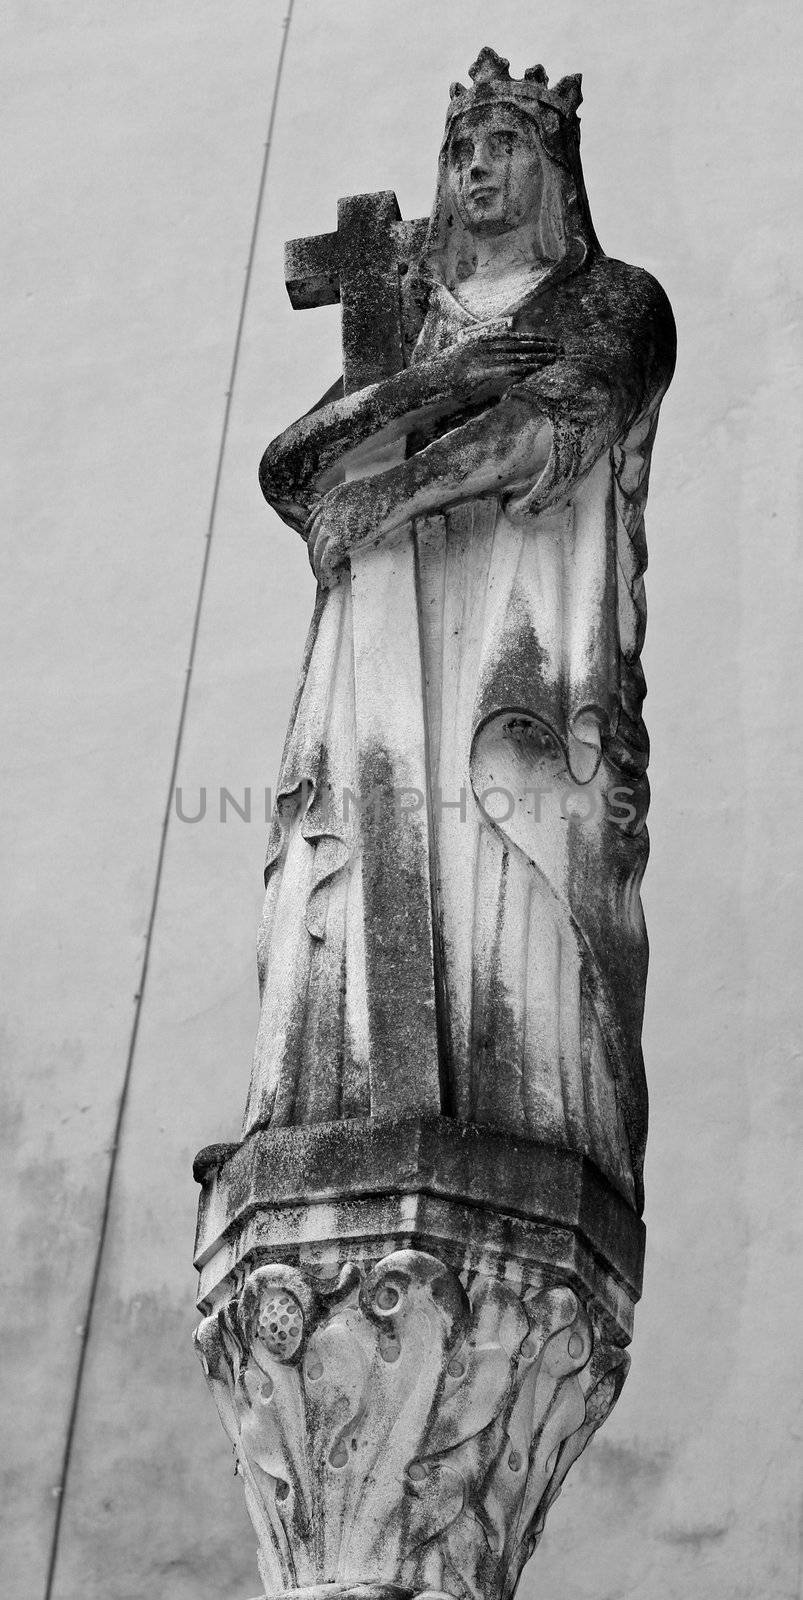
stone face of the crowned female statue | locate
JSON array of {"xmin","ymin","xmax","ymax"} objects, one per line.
[{"xmin": 448, "ymin": 106, "xmax": 542, "ymax": 234}]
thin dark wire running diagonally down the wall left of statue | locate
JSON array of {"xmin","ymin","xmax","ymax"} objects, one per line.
[{"xmin": 45, "ymin": 0, "xmax": 294, "ymax": 1600}]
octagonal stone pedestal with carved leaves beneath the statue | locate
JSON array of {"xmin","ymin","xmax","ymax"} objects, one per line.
[{"xmin": 197, "ymin": 1117, "xmax": 643, "ymax": 1600}]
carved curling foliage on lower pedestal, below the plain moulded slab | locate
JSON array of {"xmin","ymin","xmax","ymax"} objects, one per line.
[{"xmin": 195, "ymin": 1250, "xmax": 629, "ymax": 1600}]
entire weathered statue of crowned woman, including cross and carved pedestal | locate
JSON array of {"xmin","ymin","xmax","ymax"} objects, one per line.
[{"xmin": 198, "ymin": 48, "xmax": 675, "ymax": 1600}]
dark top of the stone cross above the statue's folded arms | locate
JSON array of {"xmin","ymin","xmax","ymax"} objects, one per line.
[{"xmin": 285, "ymin": 189, "xmax": 427, "ymax": 394}]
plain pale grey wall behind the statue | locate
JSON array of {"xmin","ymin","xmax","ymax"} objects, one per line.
[{"xmin": 0, "ymin": 0, "xmax": 803, "ymax": 1600}]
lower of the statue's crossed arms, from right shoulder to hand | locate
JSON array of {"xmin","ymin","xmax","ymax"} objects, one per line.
[{"xmin": 307, "ymin": 262, "xmax": 675, "ymax": 582}]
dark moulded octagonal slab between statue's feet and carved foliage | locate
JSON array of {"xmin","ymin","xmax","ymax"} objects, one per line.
[{"xmin": 195, "ymin": 1117, "xmax": 645, "ymax": 1341}]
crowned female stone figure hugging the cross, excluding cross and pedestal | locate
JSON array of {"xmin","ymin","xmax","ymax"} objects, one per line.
[{"xmin": 245, "ymin": 50, "xmax": 675, "ymax": 1208}]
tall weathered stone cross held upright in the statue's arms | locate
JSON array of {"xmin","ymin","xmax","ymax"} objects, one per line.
[{"xmin": 285, "ymin": 189, "xmax": 443, "ymax": 1117}]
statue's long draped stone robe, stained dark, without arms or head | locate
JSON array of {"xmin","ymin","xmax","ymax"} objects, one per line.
[{"xmin": 245, "ymin": 251, "xmax": 673, "ymax": 1206}]
